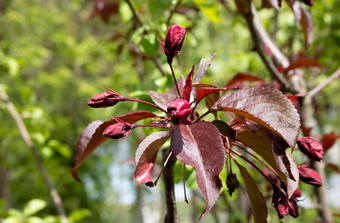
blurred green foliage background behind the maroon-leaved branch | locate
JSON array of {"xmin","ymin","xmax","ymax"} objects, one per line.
[{"xmin": 0, "ymin": 0, "xmax": 340, "ymax": 223}]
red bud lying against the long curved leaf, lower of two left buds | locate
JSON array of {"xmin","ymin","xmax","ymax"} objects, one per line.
[{"xmin": 103, "ymin": 118, "xmax": 133, "ymax": 139}]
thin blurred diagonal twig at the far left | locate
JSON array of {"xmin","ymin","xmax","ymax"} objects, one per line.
[{"xmin": 0, "ymin": 91, "xmax": 68, "ymax": 223}]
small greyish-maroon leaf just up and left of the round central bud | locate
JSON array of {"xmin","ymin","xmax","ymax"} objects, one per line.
[{"xmin": 148, "ymin": 75, "xmax": 185, "ymax": 111}]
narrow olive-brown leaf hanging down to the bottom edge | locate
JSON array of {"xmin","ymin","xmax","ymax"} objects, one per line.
[{"xmin": 235, "ymin": 162, "xmax": 267, "ymax": 223}]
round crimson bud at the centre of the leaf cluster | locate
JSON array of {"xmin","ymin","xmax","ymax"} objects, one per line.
[{"xmin": 168, "ymin": 99, "xmax": 191, "ymax": 121}]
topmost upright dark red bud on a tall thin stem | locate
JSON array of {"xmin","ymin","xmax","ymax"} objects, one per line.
[{"xmin": 159, "ymin": 25, "xmax": 186, "ymax": 64}]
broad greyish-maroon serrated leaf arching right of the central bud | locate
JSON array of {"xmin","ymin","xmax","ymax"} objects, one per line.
[{"xmin": 211, "ymin": 86, "xmax": 300, "ymax": 147}]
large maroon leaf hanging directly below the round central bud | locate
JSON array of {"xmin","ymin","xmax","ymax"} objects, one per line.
[{"xmin": 171, "ymin": 121, "xmax": 225, "ymax": 218}]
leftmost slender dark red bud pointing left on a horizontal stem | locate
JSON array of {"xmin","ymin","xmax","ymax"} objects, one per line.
[{"xmin": 87, "ymin": 90, "xmax": 126, "ymax": 108}]
